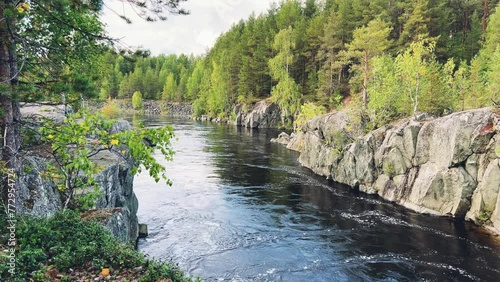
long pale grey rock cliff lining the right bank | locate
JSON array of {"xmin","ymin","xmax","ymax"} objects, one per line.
[{"xmin": 275, "ymin": 108, "xmax": 500, "ymax": 234}]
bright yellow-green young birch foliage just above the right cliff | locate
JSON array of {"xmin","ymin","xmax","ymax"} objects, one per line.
[{"xmin": 368, "ymin": 38, "xmax": 458, "ymax": 125}]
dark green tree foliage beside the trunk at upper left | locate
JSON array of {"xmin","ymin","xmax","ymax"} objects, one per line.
[{"xmin": 6, "ymin": 0, "xmax": 104, "ymax": 104}]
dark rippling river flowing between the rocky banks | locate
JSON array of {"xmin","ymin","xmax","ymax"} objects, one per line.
[{"xmin": 135, "ymin": 115, "xmax": 500, "ymax": 281}]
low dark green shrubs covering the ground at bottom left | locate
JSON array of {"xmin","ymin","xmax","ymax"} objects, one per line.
[{"xmin": 0, "ymin": 211, "xmax": 200, "ymax": 282}]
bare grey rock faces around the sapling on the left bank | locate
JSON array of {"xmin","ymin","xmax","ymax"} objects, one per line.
[{"xmin": 16, "ymin": 108, "xmax": 138, "ymax": 242}]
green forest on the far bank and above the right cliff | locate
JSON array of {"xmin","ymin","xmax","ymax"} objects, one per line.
[{"xmin": 94, "ymin": 0, "xmax": 500, "ymax": 126}]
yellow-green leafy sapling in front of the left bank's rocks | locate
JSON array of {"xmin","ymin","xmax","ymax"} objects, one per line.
[{"xmin": 40, "ymin": 113, "xmax": 173, "ymax": 210}]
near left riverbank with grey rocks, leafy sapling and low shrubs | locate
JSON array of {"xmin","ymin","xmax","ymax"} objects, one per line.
[{"xmin": 7, "ymin": 105, "xmax": 197, "ymax": 281}]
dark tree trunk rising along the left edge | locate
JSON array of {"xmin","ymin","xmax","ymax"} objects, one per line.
[{"xmin": 0, "ymin": 0, "xmax": 21, "ymax": 206}]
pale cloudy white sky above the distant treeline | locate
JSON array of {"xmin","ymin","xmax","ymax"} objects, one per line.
[{"xmin": 101, "ymin": 0, "xmax": 275, "ymax": 55}]
